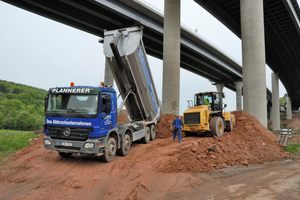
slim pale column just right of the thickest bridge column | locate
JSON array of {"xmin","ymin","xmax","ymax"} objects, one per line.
[{"xmin": 270, "ymin": 73, "xmax": 280, "ymax": 130}]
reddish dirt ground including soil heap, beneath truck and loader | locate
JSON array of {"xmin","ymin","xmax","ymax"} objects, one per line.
[{"xmin": 0, "ymin": 112, "xmax": 300, "ymax": 199}]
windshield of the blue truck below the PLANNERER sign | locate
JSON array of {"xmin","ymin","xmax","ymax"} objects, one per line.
[{"xmin": 46, "ymin": 94, "xmax": 98, "ymax": 117}]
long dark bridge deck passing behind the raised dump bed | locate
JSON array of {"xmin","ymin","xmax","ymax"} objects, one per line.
[{"xmin": 3, "ymin": 0, "xmax": 242, "ymax": 91}]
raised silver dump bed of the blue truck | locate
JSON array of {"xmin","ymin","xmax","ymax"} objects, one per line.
[{"xmin": 103, "ymin": 27, "xmax": 161, "ymax": 121}]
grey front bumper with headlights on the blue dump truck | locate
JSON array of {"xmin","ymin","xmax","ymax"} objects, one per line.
[{"xmin": 44, "ymin": 135, "xmax": 105, "ymax": 155}]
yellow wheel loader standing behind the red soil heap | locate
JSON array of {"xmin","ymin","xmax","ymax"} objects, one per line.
[{"xmin": 182, "ymin": 91, "xmax": 235, "ymax": 137}]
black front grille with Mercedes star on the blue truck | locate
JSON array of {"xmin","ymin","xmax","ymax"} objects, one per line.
[{"xmin": 45, "ymin": 125, "xmax": 93, "ymax": 141}]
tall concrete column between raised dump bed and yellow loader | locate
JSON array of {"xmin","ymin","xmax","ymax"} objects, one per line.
[{"xmin": 162, "ymin": 0, "xmax": 180, "ymax": 115}]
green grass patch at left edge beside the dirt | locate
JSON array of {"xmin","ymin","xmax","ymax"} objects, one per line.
[{"xmin": 0, "ymin": 129, "xmax": 38, "ymax": 164}]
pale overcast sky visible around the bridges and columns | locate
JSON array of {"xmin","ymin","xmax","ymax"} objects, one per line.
[{"xmin": 0, "ymin": 0, "xmax": 290, "ymax": 115}]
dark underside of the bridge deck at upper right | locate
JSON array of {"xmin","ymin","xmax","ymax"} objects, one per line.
[{"xmin": 194, "ymin": 0, "xmax": 300, "ymax": 109}]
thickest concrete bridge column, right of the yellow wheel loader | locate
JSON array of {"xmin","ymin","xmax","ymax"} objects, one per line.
[{"xmin": 240, "ymin": 0, "xmax": 267, "ymax": 127}]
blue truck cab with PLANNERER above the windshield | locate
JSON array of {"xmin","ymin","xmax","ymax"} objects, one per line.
[{"xmin": 44, "ymin": 86, "xmax": 117, "ymax": 157}]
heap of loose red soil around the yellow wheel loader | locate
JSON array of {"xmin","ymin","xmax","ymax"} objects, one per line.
[{"xmin": 155, "ymin": 111, "xmax": 291, "ymax": 173}]
